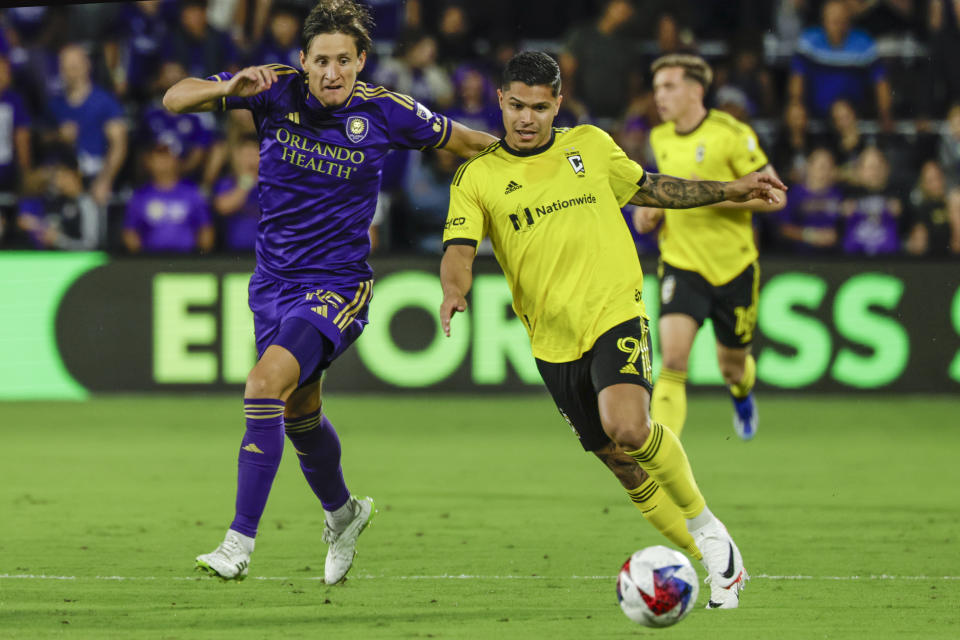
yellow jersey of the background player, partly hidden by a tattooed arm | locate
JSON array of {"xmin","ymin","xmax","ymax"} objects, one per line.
[{"xmin": 650, "ymin": 109, "xmax": 767, "ymax": 286}]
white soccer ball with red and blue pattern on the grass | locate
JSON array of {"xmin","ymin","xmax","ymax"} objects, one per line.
[{"xmin": 617, "ymin": 545, "xmax": 700, "ymax": 627}]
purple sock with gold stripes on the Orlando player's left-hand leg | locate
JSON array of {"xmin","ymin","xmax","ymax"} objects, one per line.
[{"xmin": 230, "ymin": 398, "xmax": 285, "ymax": 538}]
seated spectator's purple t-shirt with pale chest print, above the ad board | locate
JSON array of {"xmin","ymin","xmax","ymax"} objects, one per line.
[{"xmin": 123, "ymin": 180, "xmax": 212, "ymax": 253}]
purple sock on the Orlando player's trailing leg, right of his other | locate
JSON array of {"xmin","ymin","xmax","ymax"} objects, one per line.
[{"xmin": 285, "ymin": 409, "xmax": 350, "ymax": 511}]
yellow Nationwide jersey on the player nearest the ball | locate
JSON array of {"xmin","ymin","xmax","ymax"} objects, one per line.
[{"xmin": 443, "ymin": 125, "xmax": 646, "ymax": 362}]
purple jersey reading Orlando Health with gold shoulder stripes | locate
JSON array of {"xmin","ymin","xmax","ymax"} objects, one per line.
[{"xmin": 211, "ymin": 65, "xmax": 450, "ymax": 284}]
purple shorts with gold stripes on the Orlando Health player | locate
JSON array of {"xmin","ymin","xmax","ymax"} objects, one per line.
[{"xmin": 249, "ymin": 271, "xmax": 373, "ymax": 383}]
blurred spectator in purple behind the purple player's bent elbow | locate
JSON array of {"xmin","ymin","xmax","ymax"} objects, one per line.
[{"xmin": 140, "ymin": 61, "xmax": 223, "ymax": 187}]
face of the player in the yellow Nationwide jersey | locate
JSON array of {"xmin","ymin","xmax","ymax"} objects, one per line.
[{"xmin": 497, "ymin": 82, "xmax": 563, "ymax": 149}]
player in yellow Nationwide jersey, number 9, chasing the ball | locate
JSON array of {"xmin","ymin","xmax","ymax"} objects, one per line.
[{"xmin": 440, "ymin": 52, "xmax": 784, "ymax": 609}]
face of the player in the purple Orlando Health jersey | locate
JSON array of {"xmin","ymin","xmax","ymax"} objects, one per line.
[{"xmin": 300, "ymin": 33, "xmax": 367, "ymax": 107}]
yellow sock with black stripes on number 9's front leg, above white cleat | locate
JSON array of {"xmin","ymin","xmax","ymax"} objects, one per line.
[{"xmin": 627, "ymin": 422, "xmax": 706, "ymax": 519}]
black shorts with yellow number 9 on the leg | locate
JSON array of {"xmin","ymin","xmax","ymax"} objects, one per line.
[{"xmin": 537, "ymin": 317, "xmax": 653, "ymax": 451}]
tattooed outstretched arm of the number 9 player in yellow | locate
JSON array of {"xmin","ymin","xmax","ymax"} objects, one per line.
[{"xmin": 630, "ymin": 172, "xmax": 787, "ymax": 209}]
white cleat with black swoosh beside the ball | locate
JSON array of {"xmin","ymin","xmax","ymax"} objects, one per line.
[{"xmin": 690, "ymin": 518, "xmax": 750, "ymax": 609}]
